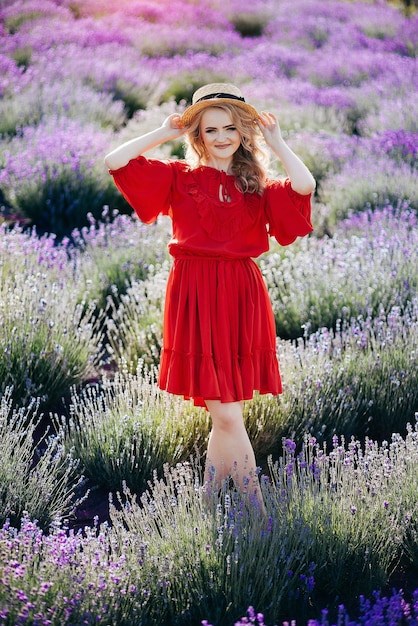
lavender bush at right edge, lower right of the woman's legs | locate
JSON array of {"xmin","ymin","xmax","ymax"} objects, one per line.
[{"xmin": 272, "ymin": 427, "xmax": 417, "ymax": 602}]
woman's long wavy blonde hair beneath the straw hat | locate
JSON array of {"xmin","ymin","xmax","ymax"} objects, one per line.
[{"xmin": 185, "ymin": 103, "xmax": 268, "ymax": 194}]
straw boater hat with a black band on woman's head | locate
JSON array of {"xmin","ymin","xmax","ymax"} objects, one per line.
[{"xmin": 181, "ymin": 83, "xmax": 260, "ymax": 126}]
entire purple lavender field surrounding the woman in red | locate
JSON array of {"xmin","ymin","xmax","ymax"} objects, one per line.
[{"xmin": 0, "ymin": 0, "xmax": 418, "ymax": 626}]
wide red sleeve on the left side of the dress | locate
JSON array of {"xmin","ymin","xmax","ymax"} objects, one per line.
[{"xmin": 109, "ymin": 156, "xmax": 173, "ymax": 224}]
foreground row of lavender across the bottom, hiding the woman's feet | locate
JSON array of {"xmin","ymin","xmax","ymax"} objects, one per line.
[{"xmin": 0, "ymin": 420, "xmax": 418, "ymax": 626}]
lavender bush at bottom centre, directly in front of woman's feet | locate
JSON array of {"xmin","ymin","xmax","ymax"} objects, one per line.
[{"xmin": 108, "ymin": 464, "xmax": 313, "ymax": 624}]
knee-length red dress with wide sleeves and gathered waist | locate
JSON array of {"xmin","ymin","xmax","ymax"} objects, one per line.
[{"xmin": 110, "ymin": 156, "xmax": 312, "ymax": 406}]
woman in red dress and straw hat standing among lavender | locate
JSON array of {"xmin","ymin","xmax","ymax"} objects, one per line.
[{"xmin": 105, "ymin": 83, "xmax": 315, "ymax": 507}]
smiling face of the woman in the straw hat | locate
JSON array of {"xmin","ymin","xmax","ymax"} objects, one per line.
[{"xmin": 200, "ymin": 107, "xmax": 241, "ymax": 170}]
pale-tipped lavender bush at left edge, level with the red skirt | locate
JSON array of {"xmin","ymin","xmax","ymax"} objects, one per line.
[{"xmin": 0, "ymin": 224, "xmax": 99, "ymax": 407}]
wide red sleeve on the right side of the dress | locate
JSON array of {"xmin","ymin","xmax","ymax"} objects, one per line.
[{"xmin": 264, "ymin": 178, "xmax": 313, "ymax": 246}]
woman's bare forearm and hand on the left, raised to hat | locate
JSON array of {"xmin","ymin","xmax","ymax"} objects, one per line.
[{"xmin": 104, "ymin": 113, "xmax": 186, "ymax": 170}]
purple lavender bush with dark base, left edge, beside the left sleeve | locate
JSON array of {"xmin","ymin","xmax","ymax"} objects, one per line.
[{"xmin": 0, "ymin": 120, "xmax": 131, "ymax": 237}]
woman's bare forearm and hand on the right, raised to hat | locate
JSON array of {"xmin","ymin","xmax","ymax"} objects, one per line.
[{"xmin": 258, "ymin": 111, "xmax": 316, "ymax": 195}]
